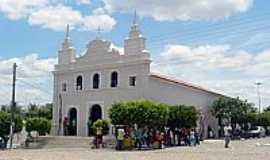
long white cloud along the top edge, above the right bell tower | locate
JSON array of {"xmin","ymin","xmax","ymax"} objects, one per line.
[{"xmin": 103, "ymin": 0, "xmax": 253, "ymax": 21}]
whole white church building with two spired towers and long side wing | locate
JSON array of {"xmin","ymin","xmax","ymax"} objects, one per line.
[{"xmin": 52, "ymin": 14, "xmax": 223, "ymax": 136}]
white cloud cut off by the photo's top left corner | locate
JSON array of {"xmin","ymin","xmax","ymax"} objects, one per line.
[{"xmin": 0, "ymin": 0, "xmax": 48, "ymax": 20}]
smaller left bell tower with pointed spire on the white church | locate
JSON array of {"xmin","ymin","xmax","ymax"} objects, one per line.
[{"xmin": 58, "ymin": 25, "xmax": 76, "ymax": 64}]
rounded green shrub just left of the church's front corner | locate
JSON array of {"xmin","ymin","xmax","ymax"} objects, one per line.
[{"xmin": 26, "ymin": 117, "xmax": 51, "ymax": 135}]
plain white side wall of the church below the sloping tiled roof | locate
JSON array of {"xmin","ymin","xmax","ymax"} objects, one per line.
[{"xmin": 145, "ymin": 76, "xmax": 219, "ymax": 136}]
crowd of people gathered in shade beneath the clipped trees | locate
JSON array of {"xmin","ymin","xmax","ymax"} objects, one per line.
[{"xmin": 115, "ymin": 125, "xmax": 200, "ymax": 150}]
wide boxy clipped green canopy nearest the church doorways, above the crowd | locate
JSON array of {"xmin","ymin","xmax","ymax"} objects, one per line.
[{"xmin": 109, "ymin": 100, "xmax": 168, "ymax": 127}]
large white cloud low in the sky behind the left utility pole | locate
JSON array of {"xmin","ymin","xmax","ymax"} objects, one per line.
[{"xmin": 0, "ymin": 54, "xmax": 56, "ymax": 105}]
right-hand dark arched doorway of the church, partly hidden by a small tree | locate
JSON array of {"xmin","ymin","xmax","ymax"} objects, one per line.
[{"xmin": 88, "ymin": 104, "xmax": 102, "ymax": 136}]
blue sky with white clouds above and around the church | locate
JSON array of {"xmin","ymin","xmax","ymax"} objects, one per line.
[{"xmin": 0, "ymin": 0, "xmax": 270, "ymax": 110}]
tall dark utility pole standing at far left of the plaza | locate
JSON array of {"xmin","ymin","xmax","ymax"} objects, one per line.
[{"xmin": 9, "ymin": 63, "xmax": 17, "ymax": 149}]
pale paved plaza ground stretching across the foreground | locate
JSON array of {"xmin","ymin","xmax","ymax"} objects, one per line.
[{"xmin": 0, "ymin": 138, "xmax": 270, "ymax": 160}]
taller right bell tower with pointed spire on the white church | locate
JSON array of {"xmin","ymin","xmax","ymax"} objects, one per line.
[{"xmin": 124, "ymin": 11, "xmax": 146, "ymax": 55}]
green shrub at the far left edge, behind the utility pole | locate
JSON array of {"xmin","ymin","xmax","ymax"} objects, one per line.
[{"xmin": 0, "ymin": 111, "xmax": 23, "ymax": 136}]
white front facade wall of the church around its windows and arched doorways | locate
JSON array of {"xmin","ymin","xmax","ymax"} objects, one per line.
[{"xmin": 54, "ymin": 62, "xmax": 149, "ymax": 136}]
